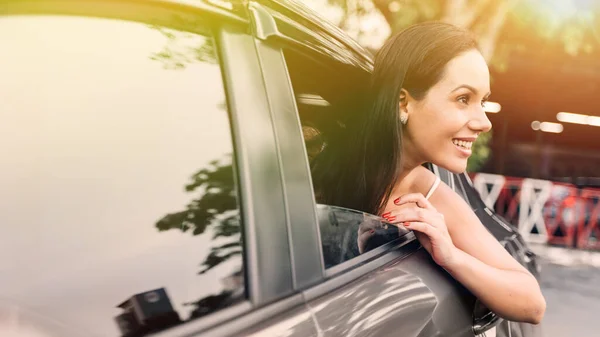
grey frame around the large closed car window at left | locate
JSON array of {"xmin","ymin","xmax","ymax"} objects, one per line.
[{"xmin": 0, "ymin": 0, "xmax": 301, "ymax": 336}]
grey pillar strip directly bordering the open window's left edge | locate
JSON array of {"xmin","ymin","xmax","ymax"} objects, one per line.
[{"xmin": 250, "ymin": 3, "xmax": 323, "ymax": 290}]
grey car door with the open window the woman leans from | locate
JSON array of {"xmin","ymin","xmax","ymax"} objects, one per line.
[{"xmin": 250, "ymin": 3, "xmax": 494, "ymax": 336}]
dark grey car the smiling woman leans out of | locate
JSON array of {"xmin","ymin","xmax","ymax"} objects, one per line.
[{"xmin": 0, "ymin": 0, "xmax": 538, "ymax": 337}]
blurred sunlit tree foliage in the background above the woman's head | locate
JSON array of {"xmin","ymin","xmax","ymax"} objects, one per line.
[{"xmin": 326, "ymin": 0, "xmax": 600, "ymax": 63}]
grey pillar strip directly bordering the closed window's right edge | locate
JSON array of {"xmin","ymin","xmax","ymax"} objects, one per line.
[{"xmin": 222, "ymin": 23, "xmax": 293, "ymax": 305}]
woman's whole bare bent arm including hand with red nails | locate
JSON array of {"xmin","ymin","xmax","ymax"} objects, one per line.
[{"xmin": 388, "ymin": 177, "xmax": 546, "ymax": 324}]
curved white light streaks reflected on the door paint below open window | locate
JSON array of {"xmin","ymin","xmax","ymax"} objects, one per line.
[{"xmin": 310, "ymin": 268, "xmax": 437, "ymax": 337}]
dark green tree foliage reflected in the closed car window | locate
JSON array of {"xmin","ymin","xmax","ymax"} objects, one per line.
[{"xmin": 149, "ymin": 19, "xmax": 237, "ymax": 274}]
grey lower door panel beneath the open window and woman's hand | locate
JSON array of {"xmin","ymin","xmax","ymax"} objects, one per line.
[{"xmin": 309, "ymin": 247, "xmax": 474, "ymax": 337}]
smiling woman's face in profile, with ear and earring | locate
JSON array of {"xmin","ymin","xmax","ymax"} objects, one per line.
[{"xmin": 400, "ymin": 49, "xmax": 492, "ymax": 173}]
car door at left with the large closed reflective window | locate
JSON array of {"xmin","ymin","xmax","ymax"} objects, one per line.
[{"xmin": 0, "ymin": 0, "xmax": 317, "ymax": 337}]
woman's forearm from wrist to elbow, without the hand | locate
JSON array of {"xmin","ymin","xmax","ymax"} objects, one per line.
[{"xmin": 445, "ymin": 248, "xmax": 546, "ymax": 324}]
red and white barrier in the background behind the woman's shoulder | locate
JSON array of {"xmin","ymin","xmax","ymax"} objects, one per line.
[{"xmin": 472, "ymin": 173, "xmax": 600, "ymax": 249}]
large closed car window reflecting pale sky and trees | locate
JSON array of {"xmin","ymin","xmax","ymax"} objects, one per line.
[{"xmin": 0, "ymin": 15, "xmax": 246, "ymax": 336}]
